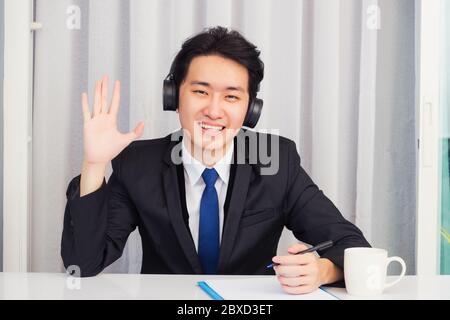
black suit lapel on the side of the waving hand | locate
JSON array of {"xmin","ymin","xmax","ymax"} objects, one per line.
[{"xmin": 163, "ymin": 134, "xmax": 201, "ymax": 274}]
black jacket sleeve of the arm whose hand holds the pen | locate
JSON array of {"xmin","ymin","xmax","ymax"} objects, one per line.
[{"xmin": 284, "ymin": 141, "xmax": 370, "ymax": 284}]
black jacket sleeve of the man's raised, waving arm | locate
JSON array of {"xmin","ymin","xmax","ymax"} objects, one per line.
[{"xmin": 61, "ymin": 151, "xmax": 137, "ymax": 277}]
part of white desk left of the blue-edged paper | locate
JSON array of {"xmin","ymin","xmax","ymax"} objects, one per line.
[{"xmin": 0, "ymin": 273, "xmax": 248, "ymax": 300}]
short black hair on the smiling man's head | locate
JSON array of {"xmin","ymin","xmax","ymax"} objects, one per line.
[{"xmin": 170, "ymin": 26, "xmax": 264, "ymax": 101}]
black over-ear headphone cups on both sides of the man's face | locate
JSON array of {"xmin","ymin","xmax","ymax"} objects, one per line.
[{"xmin": 163, "ymin": 67, "xmax": 263, "ymax": 128}]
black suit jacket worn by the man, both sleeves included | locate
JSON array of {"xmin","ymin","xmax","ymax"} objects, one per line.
[{"xmin": 61, "ymin": 130, "xmax": 369, "ymax": 276}]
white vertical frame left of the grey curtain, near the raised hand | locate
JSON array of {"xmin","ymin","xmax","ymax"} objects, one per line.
[{"xmin": 3, "ymin": 0, "xmax": 32, "ymax": 272}]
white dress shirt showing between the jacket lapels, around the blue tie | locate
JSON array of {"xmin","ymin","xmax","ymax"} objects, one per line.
[{"xmin": 181, "ymin": 140, "xmax": 234, "ymax": 251}]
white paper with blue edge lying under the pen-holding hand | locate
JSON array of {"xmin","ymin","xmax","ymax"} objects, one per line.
[{"xmin": 200, "ymin": 276, "xmax": 337, "ymax": 300}]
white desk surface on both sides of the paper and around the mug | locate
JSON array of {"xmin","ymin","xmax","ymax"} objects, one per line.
[{"xmin": 0, "ymin": 273, "xmax": 450, "ymax": 300}]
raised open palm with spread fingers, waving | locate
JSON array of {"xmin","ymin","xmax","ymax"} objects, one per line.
[{"xmin": 82, "ymin": 76, "xmax": 144, "ymax": 164}]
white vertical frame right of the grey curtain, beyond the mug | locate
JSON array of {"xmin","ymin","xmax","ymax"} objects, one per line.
[{"xmin": 416, "ymin": 0, "xmax": 441, "ymax": 275}]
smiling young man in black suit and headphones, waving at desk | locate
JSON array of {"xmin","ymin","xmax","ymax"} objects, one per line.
[{"xmin": 61, "ymin": 27, "xmax": 369, "ymax": 294}]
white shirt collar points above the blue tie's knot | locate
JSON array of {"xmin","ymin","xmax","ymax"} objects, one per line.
[{"xmin": 181, "ymin": 139, "xmax": 234, "ymax": 186}]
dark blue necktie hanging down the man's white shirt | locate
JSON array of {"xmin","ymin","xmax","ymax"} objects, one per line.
[{"xmin": 198, "ymin": 169, "xmax": 219, "ymax": 274}]
